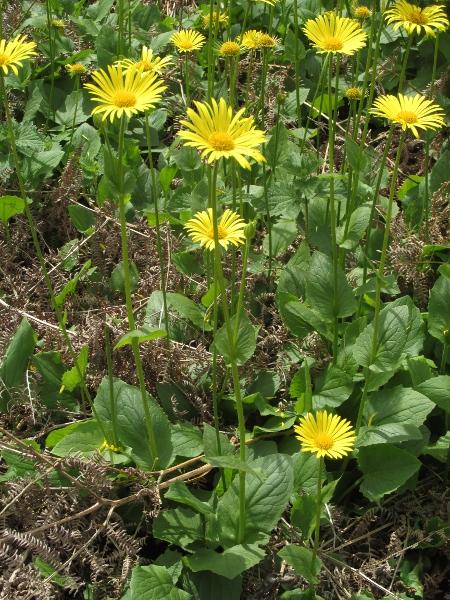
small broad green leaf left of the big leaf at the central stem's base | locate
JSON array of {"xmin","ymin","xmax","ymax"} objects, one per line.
[{"xmin": 153, "ymin": 508, "xmax": 204, "ymax": 548}]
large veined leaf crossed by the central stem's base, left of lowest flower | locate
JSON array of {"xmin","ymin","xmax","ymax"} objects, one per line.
[{"xmin": 216, "ymin": 454, "xmax": 294, "ymax": 548}]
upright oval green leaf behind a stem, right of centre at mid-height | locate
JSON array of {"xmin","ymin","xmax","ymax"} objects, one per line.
[{"xmin": 306, "ymin": 251, "xmax": 356, "ymax": 323}]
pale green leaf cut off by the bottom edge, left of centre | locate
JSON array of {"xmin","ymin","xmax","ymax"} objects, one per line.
[{"xmin": 122, "ymin": 565, "xmax": 192, "ymax": 600}]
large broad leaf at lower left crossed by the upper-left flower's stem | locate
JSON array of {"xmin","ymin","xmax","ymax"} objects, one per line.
[{"xmin": 94, "ymin": 377, "xmax": 174, "ymax": 471}]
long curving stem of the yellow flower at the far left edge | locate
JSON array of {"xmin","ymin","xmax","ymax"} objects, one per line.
[{"xmin": 0, "ymin": 72, "xmax": 107, "ymax": 439}]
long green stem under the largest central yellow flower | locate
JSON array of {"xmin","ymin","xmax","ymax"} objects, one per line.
[{"xmin": 211, "ymin": 161, "xmax": 245, "ymax": 544}]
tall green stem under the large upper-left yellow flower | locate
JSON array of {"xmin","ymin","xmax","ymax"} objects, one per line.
[{"xmin": 115, "ymin": 117, "xmax": 158, "ymax": 464}]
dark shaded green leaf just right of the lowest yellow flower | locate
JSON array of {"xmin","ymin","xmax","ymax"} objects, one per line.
[{"xmin": 357, "ymin": 444, "xmax": 421, "ymax": 502}]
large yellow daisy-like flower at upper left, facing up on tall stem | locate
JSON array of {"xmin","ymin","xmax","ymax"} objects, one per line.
[{"xmin": 85, "ymin": 64, "xmax": 166, "ymax": 123}]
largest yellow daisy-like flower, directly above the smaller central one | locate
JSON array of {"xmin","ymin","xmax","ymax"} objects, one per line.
[{"xmin": 178, "ymin": 98, "xmax": 266, "ymax": 169}]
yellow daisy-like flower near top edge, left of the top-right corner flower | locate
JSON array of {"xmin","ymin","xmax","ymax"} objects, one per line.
[{"xmin": 303, "ymin": 12, "xmax": 367, "ymax": 55}]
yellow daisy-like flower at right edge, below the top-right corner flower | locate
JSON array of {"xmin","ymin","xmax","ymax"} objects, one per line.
[{"xmin": 369, "ymin": 94, "xmax": 445, "ymax": 137}]
